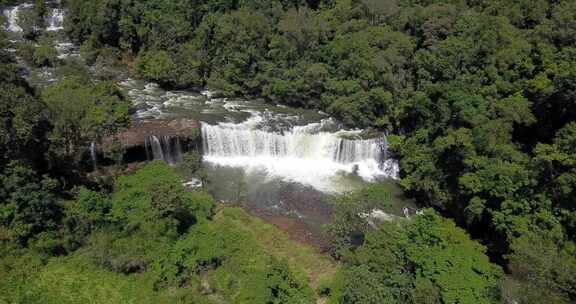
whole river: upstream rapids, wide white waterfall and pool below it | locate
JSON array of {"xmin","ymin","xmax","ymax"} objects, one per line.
[{"xmin": 3, "ymin": 3, "xmax": 414, "ymax": 233}]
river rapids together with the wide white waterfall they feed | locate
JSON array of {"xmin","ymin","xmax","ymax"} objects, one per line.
[{"xmin": 121, "ymin": 80, "xmax": 398, "ymax": 193}]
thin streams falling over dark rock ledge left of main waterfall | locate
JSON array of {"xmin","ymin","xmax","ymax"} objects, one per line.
[{"xmin": 146, "ymin": 135, "xmax": 183, "ymax": 164}]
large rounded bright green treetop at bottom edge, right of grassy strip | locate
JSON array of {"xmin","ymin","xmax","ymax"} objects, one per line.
[{"xmin": 330, "ymin": 211, "xmax": 502, "ymax": 303}]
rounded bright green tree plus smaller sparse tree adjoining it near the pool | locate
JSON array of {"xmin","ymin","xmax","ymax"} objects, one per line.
[{"xmin": 323, "ymin": 185, "xmax": 503, "ymax": 303}]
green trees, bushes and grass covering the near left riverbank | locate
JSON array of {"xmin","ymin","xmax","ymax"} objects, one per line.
[{"xmin": 0, "ymin": 37, "xmax": 324, "ymax": 303}]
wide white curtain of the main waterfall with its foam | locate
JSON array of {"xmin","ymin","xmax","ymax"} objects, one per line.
[{"xmin": 202, "ymin": 120, "xmax": 398, "ymax": 192}]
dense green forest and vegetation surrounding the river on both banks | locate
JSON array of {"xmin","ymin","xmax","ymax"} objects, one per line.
[{"xmin": 0, "ymin": 0, "xmax": 576, "ymax": 304}]
